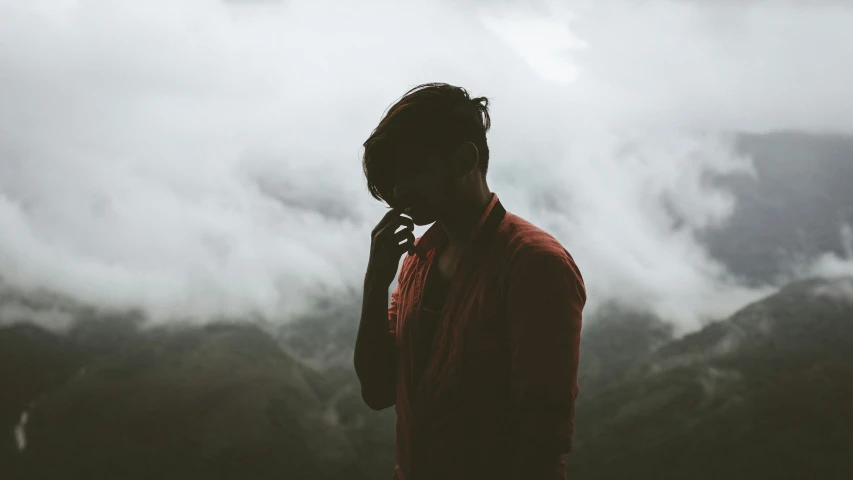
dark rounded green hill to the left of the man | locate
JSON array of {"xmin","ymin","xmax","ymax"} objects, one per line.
[{"xmin": 0, "ymin": 318, "xmax": 382, "ymax": 479}]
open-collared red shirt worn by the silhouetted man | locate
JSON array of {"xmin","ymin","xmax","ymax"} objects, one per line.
[{"xmin": 388, "ymin": 193, "xmax": 586, "ymax": 480}]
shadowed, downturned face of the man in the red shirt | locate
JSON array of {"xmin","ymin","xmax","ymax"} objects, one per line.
[{"xmin": 389, "ymin": 155, "xmax": 452, "ymax": 225}]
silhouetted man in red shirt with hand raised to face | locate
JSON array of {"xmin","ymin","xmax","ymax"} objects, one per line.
[{"xmin": 354, "ymin": 83, "xmax": 586, "ymax": 480}]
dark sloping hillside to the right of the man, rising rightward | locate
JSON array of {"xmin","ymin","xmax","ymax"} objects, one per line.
[{"xmin": 567, "ymin": 278, "xmax": 853, "ymax": 479}]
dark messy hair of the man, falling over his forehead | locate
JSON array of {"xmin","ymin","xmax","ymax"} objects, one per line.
[{"xmin": 362, "ymin": 83, "xmax": 491, "ymax": 202}]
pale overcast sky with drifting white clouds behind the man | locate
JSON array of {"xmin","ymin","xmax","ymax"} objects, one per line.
[{"xmin": 0, "ymin": 0, "xmax": 853, "ymax": 329}]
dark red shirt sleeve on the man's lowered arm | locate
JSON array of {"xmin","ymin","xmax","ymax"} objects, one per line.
[{"xmin": 507, "ymin": 248, "xmax": 586, "ymax": 458}]
